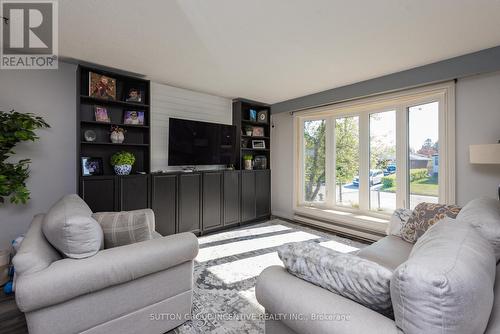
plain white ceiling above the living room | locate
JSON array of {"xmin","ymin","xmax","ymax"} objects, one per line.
[{"xmin": 59, "ymin": 0, "xmax": 500, "ymax": 103}]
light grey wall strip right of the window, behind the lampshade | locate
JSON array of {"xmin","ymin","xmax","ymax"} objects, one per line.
[{"xmin": 456, "ymin": 72, "xmax": 500, "ymax": 205}]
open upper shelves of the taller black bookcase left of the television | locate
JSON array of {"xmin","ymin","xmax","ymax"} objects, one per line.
[{"xmin": 77, "ymin": 66, "xmax": 151, "ymax": 179}]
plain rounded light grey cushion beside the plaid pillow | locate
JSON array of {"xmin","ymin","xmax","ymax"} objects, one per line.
[{"xmin": 42, "ymin": 194, "xmax": 103, "ymax": 259}]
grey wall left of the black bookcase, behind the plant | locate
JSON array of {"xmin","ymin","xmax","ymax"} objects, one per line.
[{"xmin": 0, "ymin": 62, "xmax": 76, "ymax": 249}]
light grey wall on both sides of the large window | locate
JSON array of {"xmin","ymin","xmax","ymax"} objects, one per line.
[{"xmin": 271, "ymin": 72, "xmax": 500, "ymax": 218}]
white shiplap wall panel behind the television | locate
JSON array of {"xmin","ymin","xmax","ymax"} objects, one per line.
[{"xmin": 151, "ymin": 82, "xmax": 233, "ymax": 171}]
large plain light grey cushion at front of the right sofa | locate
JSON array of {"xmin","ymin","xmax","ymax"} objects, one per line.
[{"xmin": 391, "ymin": 218, "xmax": 496, "ymax": 334}]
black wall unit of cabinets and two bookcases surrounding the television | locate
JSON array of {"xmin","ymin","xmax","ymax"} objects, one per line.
[{"xmin": 76, "ymin": 66, "xmax": 271, "ymax": 235}]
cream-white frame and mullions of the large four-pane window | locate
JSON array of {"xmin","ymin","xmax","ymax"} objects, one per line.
[{"xmin": 293, "ymin": 81, "xmax": 455, "ymax": 232}]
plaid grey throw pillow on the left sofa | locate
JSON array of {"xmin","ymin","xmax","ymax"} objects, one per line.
[{"xmin": 92, "ymin": 209, "xmax": 154, "ymax": 248}]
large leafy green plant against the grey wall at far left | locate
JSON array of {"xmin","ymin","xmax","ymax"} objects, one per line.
[{"xmin": 0, "ymin": 110, "xmax": 50, "ymax": 204}]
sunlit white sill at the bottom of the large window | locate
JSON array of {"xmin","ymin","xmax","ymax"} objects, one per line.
[{"xmin": 294, "ymin": 206, "xmax": 390, "ymax": 236}]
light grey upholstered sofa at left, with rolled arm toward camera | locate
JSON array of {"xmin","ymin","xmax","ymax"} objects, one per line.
[{"xmin": 14, "ymin": 206, "xmax": 198, "ymax": 334}]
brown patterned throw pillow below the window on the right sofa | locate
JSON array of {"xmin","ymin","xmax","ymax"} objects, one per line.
[{"xmin": 401, "ymin": 202, "xmax": 461, "ymax": 243}]
